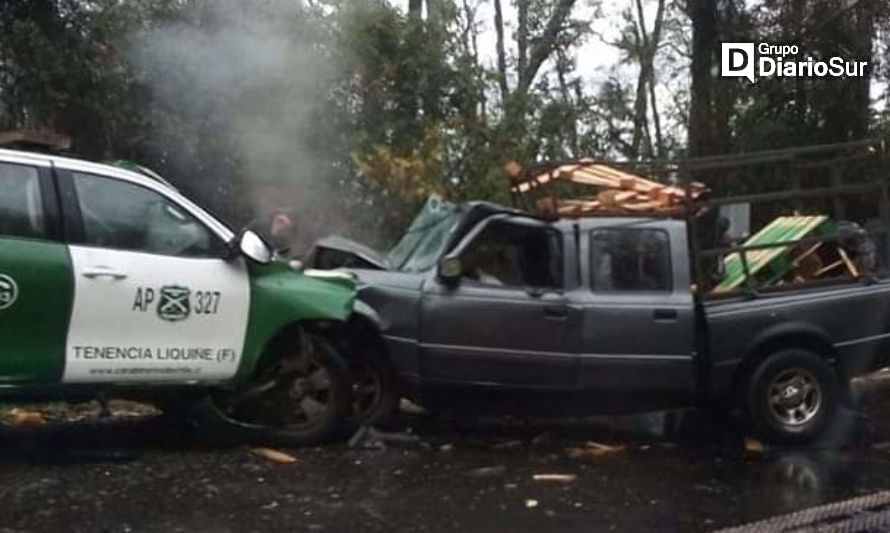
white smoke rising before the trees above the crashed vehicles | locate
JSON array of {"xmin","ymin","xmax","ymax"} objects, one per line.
[{"xmin": 131, "ymin": 0, "xmax": 349, "ymax": 249}]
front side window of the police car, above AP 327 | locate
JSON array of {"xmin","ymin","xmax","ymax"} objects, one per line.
[{"xmin": 74, "ymin": 174, "xmax": 223, "ymax": 257}]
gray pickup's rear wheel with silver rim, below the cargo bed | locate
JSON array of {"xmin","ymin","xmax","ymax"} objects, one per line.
[{"xmin": 746, "ymin": 348, "xmax": 841, "ymax": 444}]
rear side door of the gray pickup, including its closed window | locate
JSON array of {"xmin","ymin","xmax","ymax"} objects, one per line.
[{"xmin": 578, "ymin": 219, "xmax": 695, "ymax": 397}]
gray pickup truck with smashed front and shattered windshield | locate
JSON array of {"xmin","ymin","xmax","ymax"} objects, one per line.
[{"xmin": 309, "ymin": 199, "xmax": 890, "ymax": 443}]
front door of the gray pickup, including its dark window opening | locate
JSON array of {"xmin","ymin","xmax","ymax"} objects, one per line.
[{"xmin": 420, "ymin": 217, "xmax": 580, "ymax": 389}]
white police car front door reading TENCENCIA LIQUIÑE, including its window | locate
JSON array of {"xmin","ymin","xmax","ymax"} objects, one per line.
[{"xmin": 58, "ymin": 171, "xmax": 250, "ymax": 382}]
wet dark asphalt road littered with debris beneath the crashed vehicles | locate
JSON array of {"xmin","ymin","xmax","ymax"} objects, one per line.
[{"xmin": 0, "ymin": 380, "xmax": 890, "ymax": 532}]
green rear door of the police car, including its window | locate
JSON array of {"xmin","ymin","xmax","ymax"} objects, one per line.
[{"xmin": 0, "ymin": 156, "xmax": 72, "ymax": 384}]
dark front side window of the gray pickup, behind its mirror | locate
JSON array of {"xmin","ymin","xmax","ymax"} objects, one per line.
[{"xmin": 461, "ymin": 221, "xmax": 563, "ymax": 289}]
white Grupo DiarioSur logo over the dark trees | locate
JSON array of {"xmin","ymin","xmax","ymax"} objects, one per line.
[{"xmin": 720, "ymin": 43, "xmax": 868, "ymax": 83}]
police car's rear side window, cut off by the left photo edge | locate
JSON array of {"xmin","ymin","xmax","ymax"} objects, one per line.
[{"xmin": 0, "ymin": 163, "xmax": 46, "ymax": 239}]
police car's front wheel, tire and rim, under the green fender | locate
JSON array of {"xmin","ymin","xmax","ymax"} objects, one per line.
[{"xmin": 206, "ymin": 334, "xmax": 350, "ymax": 445}]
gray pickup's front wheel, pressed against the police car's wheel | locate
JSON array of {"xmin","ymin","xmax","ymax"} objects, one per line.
[{"xmin": 349, "ymin": 350, "xmax": 399, "ymax": 427}]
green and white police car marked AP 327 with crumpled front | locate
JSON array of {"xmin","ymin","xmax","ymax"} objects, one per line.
[{"xmin": 0, "ymin": 150, "xmax": 378, "ymax": 443}]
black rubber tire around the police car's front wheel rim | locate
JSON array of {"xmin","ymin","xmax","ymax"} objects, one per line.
[{"xmin": 199, "ymin": 335, "xmax": 352, "ymax": 446}]
